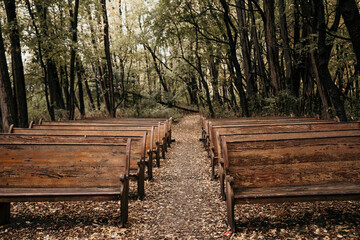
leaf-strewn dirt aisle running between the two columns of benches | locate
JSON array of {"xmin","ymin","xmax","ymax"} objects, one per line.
[{"xmin": 127, "ymin": 115, "xmax": 227, "ymax": 239}]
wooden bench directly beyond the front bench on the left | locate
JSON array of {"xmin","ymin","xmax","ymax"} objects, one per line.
[{"xmin": 0, "ymin": 132, "xmax": 146, "ymax": 200}]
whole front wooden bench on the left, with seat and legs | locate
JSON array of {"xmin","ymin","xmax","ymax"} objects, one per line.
[{"xmin": 0, "ymin": 139, "xmax": 131, "ymax": 226}]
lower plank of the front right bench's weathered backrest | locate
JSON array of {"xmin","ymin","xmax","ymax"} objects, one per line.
[{"xmin": 229, "ymin": 159, "xmax": 360, "ymax": 188}]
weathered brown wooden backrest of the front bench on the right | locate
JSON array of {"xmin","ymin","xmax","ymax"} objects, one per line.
[{"xmin": 222, "ymin": 132, "xmax": 360, "ymax": 188}]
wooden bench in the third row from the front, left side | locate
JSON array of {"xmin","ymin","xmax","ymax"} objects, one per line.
[{"xmin": 9, "ymin": 127, "xmax": 161, "ymax": 180}]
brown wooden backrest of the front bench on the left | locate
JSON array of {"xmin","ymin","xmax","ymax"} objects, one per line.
[{"xmin": 0, "ymin": 139, "xmax": 131, "ymax": 188}]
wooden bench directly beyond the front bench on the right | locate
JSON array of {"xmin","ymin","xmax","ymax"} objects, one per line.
[{"xmin": 209, "ymin": 122, "xmax": 360, "ymax": 178}]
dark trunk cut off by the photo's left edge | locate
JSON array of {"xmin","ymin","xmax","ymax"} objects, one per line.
[{"xmin": 0, "ymin": 21, "xmax": 16, "ymax": 132}]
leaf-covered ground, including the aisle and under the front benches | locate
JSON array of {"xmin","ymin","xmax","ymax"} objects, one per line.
[{"xmin": 0, "ymin": 115, "xmax": 360, "ymax": 239}]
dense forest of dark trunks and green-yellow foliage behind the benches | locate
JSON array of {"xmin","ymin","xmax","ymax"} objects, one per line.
[{"xmin": 0, "ymin": 0, "xmax": 360, "ymax": 129}]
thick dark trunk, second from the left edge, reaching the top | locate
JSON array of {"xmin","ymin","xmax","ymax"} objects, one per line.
[{"xmin": 4, "ymin": 0, "xmax": 28, "ymax": 127}]
